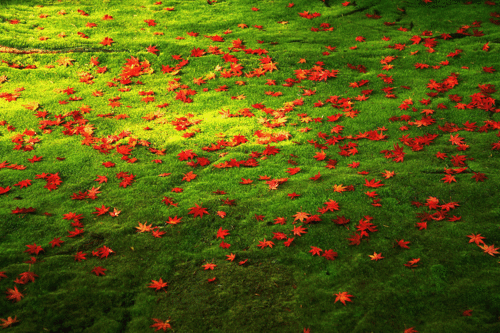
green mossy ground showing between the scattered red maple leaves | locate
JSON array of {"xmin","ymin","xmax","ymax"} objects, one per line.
[{"xmin": 0, "ymin": 0, "xmax": 500, "ymax": 333}]
